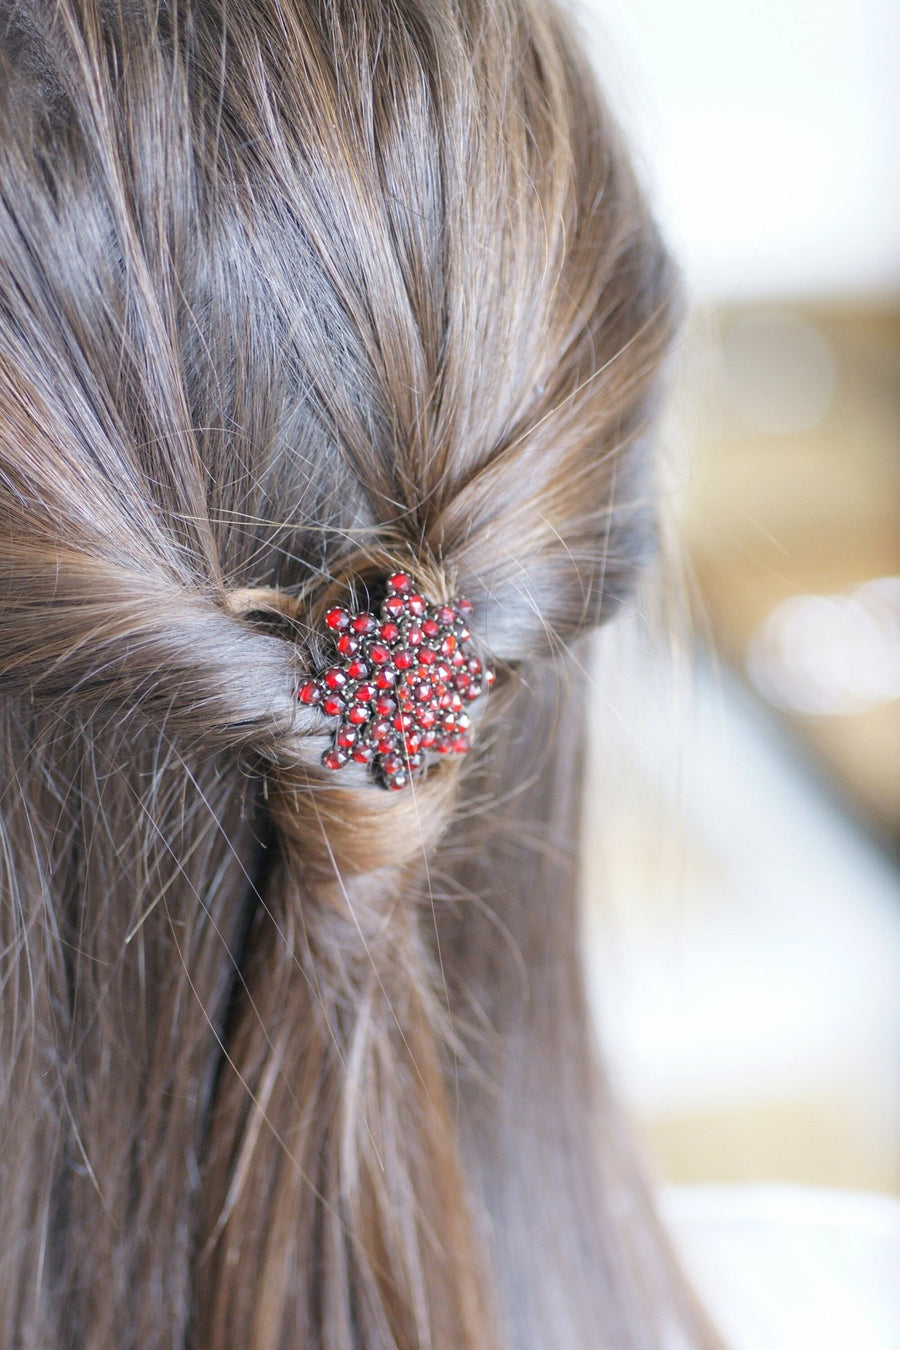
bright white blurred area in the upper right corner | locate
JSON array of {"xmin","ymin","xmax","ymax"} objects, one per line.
[{"xmin": 576, "ymin": 0, "xmax": 900, "ymax": 304}]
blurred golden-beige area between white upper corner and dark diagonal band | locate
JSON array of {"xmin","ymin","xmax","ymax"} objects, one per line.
[{"xmin": 681, "ymin": 306, "xmax": 900, "ymax": 840}]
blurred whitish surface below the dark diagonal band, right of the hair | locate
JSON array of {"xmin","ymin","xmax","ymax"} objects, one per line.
[{"xmin": 586, "ymin": 648, "xmax": 900, "ymax": 1193}]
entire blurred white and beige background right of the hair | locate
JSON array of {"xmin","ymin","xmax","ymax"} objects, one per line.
[{"xmin": 578, "ymin": 0, "xmax": 900, "ymax": 1231}]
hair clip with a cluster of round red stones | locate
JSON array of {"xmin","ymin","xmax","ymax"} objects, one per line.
[{"xmin": 298, "ymin": 572, "xmax": 494, "ymax": 790}]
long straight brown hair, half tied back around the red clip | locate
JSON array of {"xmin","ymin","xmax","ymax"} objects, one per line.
[{"xmin": 0, "ymin": 0, "xmax": 711, "ymax": 1350}]
